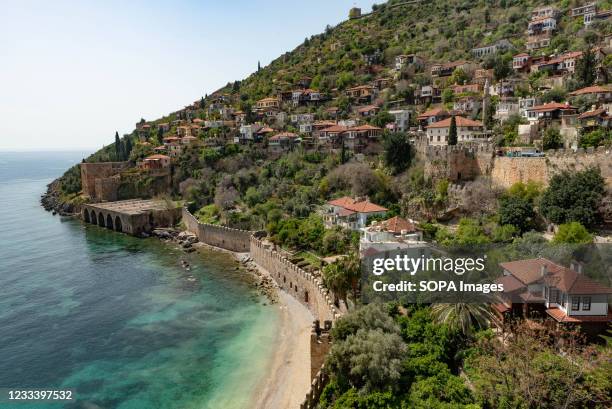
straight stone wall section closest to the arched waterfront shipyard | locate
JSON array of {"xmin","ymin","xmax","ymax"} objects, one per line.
[{"xmin": 183, "ymin": 208, "xmax": 254, "ymax": 253}]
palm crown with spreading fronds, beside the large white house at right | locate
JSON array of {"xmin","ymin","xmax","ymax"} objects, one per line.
[{"xmin": 431, "ymin": 303, "xmax": 498, "ymax": 337}]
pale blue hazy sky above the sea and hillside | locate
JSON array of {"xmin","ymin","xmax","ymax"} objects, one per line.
[{"xmin": 0, "ymin": 0, "xmax": 381, "ymax": 151}]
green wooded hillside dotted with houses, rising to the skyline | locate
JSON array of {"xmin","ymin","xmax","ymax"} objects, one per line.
[{"xmin": 49, "ymin": 0, "xmax": 612, "ymax": 234}]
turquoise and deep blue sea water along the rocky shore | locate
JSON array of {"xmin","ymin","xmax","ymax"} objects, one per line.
[{"xmin": 0, "ymin": 153, "xmax": 278, "ymax": 409}]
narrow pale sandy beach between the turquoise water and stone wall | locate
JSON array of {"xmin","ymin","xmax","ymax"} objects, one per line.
[{"xmin": 253, "ymin": 290, "xmax": 313, "ymax": 409}]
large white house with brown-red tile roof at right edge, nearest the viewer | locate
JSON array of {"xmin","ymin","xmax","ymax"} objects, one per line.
[{"xmin": 494, "ymin": 258, "xmax": 612, "ymax": 329}]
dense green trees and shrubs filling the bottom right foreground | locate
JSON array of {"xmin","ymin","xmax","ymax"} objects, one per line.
[{"xmin": 319, "ymin": 304, "xmax": 610, "ymax": 409}]
